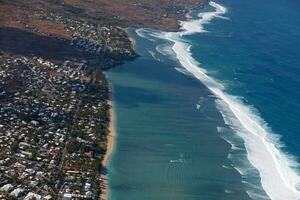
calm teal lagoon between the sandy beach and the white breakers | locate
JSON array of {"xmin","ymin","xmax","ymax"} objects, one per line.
[{"xmin": 108, "ymin": 32, "xmax": 249, "ymax": 199}]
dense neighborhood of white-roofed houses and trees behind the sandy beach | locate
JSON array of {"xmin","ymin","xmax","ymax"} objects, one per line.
[{"xmin": 0, "ymin": 55, "xmax": 109, "ymax": 199}]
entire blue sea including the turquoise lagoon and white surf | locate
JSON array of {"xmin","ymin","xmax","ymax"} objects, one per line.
[{"xmin": 107, "ymin": 0, "xmax": 300, "ymax": 200}]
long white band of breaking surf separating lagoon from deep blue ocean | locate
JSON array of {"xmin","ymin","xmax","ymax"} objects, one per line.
[{"xmin": 164, "ymin": 2, "xmax": 300, "ymax": 200}]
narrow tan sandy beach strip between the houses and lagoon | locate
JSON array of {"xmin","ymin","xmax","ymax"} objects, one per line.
[{"xmin": 100, "ymin": 100, "xmax": 116, "ymax": 200}]
